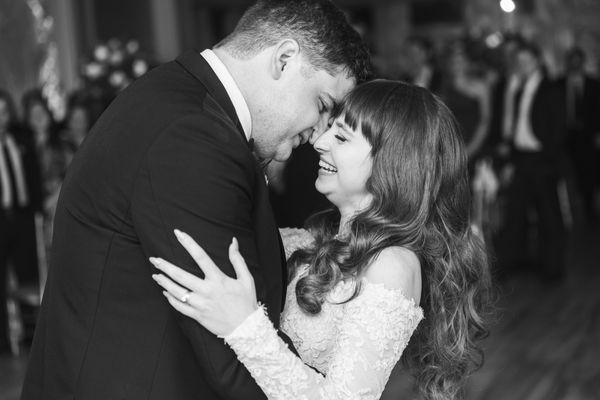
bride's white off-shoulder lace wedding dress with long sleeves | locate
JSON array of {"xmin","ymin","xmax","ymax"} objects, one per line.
[{"xmin": 224, "ymin": 230, "xmax": 423, "ymax": 400}]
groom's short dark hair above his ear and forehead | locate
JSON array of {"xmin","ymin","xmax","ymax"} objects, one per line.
[{"xmin": 215, "ymin": 0, "xmax": 371, "ymax": 82}]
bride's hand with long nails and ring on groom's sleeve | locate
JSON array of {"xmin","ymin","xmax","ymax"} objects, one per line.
[{"xmin": 150, "ymin": 230, "xmax": 258, "ymax": 337}]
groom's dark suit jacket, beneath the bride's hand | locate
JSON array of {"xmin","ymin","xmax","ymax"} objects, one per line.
[{"xmin": 22, "ymin": 51, "xmax": 286, "ymax": 400}]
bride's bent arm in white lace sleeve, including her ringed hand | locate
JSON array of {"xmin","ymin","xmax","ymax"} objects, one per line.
[{"xmin": 152, "ymin": 234, "xmax": 422, "ymax": 400}]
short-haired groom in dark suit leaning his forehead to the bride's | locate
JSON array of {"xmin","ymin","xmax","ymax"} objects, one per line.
[{"xmin": 22, "ymin": 0, "xmax": 369, "ymax": 400}]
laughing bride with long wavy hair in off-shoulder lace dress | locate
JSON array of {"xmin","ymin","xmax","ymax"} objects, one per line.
[{"xmin": 151, "ymin": 80, "xmax": 490, "ymax": 400}]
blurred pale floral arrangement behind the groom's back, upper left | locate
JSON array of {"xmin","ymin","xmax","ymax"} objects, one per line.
[{"xmin": 81, "ymin": 38, "xmax": 152, "ymax": 96}]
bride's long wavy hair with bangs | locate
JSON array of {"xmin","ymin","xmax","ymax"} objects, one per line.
[{"xmin": 289, "ymin": 80, "xmax": 491, "ymax": 400}]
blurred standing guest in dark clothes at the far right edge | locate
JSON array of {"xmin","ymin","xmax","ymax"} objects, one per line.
[{"xmin": 559, "ymin": 47, "xmax": 600, "ymax": 222}]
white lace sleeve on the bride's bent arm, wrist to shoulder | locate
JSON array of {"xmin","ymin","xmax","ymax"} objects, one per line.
[{"xmin": 225, "ymin": 282, "xmax": 423, "ymax": 400}]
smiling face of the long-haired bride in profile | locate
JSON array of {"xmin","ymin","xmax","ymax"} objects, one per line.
[{"xmin": 313, "ymin": 115, "xmax": 373, "ymax": 211}]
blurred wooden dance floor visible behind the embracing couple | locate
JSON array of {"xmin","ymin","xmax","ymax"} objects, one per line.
[{"xmin": 0, "ymin": 225, "xmax": 600, "ymax": 400}]
